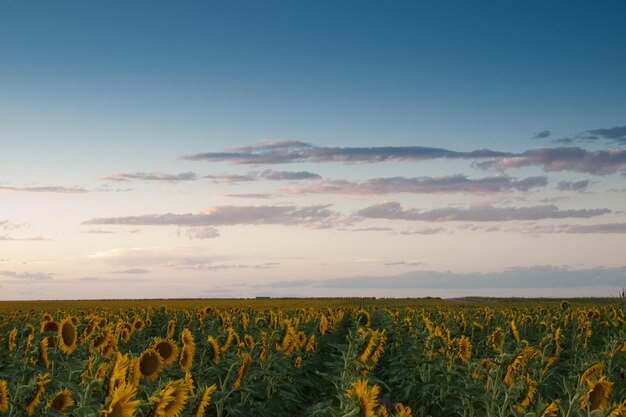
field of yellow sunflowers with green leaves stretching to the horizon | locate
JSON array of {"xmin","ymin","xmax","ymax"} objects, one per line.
[{"xmin": 0, "ymin": 299, "xmax": 626, "ymax": 417}]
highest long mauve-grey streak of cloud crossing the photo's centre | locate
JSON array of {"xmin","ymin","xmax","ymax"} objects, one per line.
[{"xmin": 180, "ymin": 140, "xmax": 512, "ymax": 165}]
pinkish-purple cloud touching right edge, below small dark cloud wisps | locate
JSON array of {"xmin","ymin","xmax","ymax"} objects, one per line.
[{"xmin": 475, "ymin": 147, "xmax": 626, "ymax": 175}]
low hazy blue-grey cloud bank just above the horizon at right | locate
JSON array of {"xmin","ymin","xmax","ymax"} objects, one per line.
[{"xmin": 266, "ymin": 265, "xmax": 626, "ymax": 289}]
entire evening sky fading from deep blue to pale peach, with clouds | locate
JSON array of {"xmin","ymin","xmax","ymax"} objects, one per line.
[{"xmin": 0, "ymin": 0, "xmax": 626, "ymax": 300}]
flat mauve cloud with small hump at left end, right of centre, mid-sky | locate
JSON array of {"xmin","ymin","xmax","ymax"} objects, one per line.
[{"xmin": 356, "ymin": 201, "xmax": 611, "ymax": 222}]
